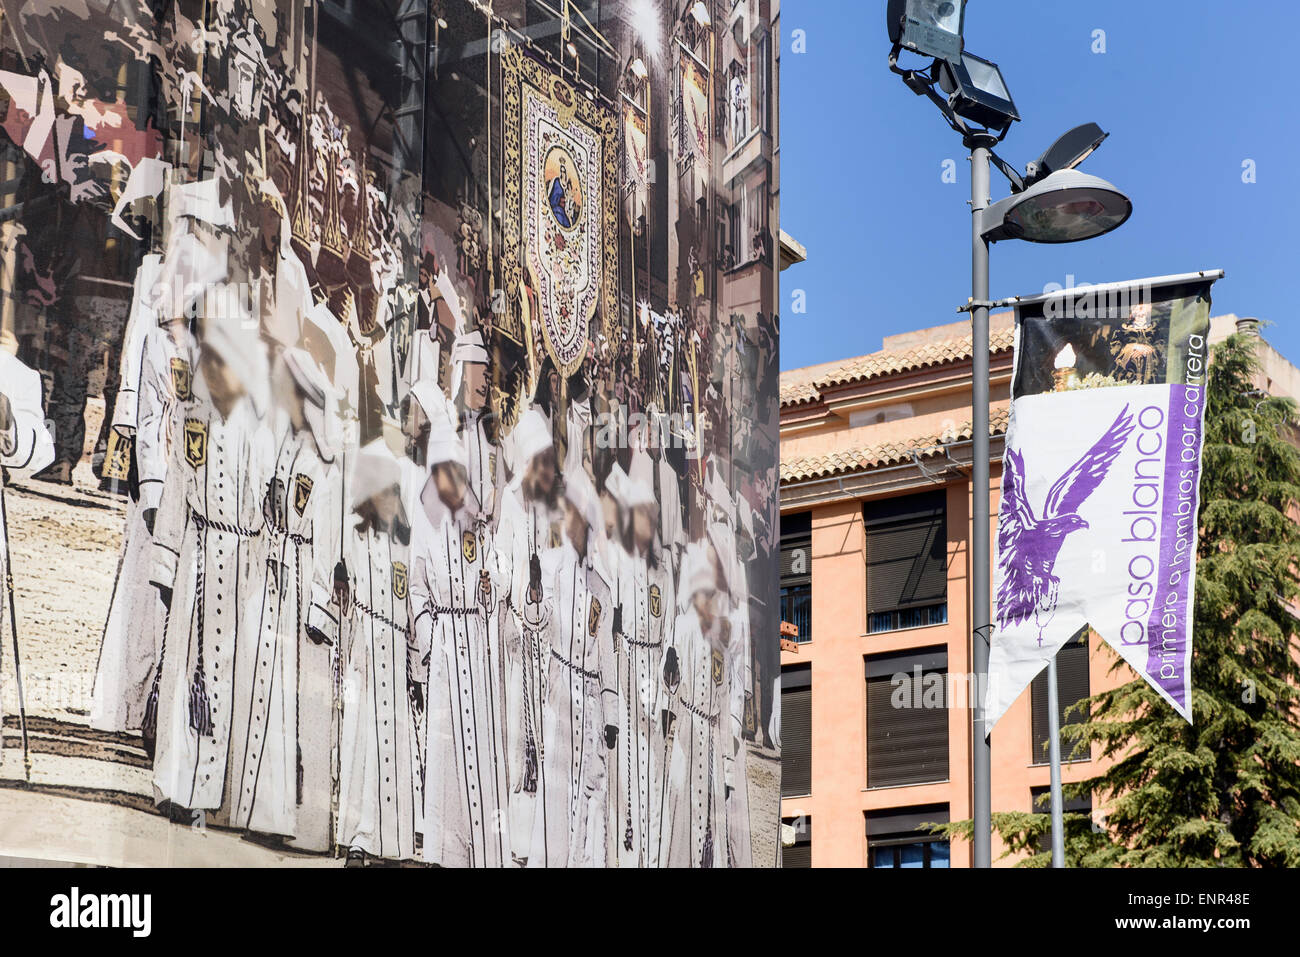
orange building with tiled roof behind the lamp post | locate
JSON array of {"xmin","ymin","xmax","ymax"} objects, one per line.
[{"xmin": 780, "ymin": 313, "xmax": 1284, "ymax": 867}]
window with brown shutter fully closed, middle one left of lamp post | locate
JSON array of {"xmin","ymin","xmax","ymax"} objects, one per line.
[{"xmin": 865, "ymin": 648, "xmax": 948, "ymax": 788}]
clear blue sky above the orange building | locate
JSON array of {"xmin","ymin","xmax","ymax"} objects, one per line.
[{"xmin": 781, "ymin": 0, "xmax": 1300, "ymax": 369}]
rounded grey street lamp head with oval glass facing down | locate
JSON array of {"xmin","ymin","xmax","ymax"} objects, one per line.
[{"xmin": 983, "ymin": 169, "xmax": 1134, "ymax": 243}]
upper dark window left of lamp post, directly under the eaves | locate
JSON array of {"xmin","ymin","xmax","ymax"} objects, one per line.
[{"xmin": 862, "ymin": 489, "xmax": 948, "ymax": 633}]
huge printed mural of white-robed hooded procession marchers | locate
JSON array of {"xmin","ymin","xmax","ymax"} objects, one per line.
[{"xmin": 0, "ymin": 0, "xmax": 780, "ymax": 867}]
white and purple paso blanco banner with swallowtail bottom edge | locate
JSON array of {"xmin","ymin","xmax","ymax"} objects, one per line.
[{"xmin": 984, "ymin": 272, "xmax": 1222, "ymax": 733}]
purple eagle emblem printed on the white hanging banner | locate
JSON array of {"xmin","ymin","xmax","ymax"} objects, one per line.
[{"xmin": 997, "ymin": 406, "xmax": 1134, "ymax": 645}]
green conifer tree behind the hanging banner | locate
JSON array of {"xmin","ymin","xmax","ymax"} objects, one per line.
[{"xmin": 943, "ymin": 334, "xmax": 1300, "ymax": 867}]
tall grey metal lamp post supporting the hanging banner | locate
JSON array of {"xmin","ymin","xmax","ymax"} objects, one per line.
[{"xmin": 967, "ymin": 137, "xmax": 993, "ymax": 867}]
